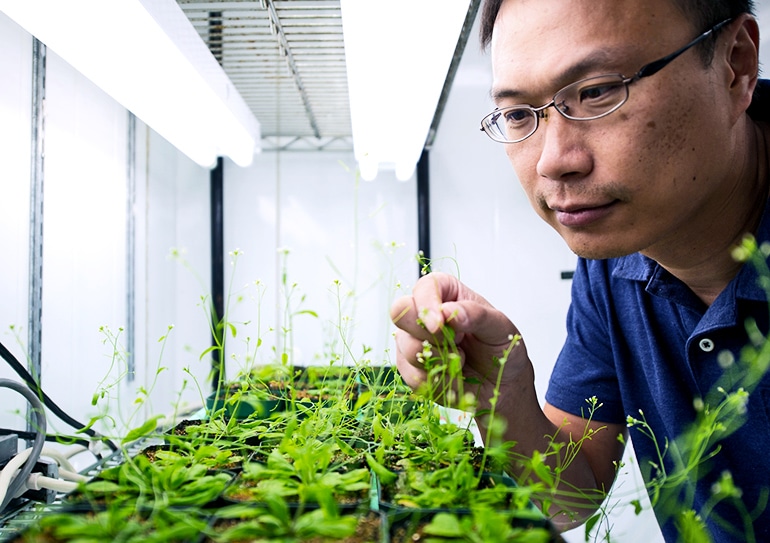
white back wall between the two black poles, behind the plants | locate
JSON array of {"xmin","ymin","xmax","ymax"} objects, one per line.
[{"xmin": 219, "ymin": 152, "xmax": 418, "ymax": 377}]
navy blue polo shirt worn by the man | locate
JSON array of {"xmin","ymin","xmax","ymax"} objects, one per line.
[{"xmin": 546, "ymin": 81, "xmax": 770, "ymax": 542}]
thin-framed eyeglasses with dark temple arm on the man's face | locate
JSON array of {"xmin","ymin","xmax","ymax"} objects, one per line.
[{"xmin": 481, "ymin": 19, "xmax": 732, "ymax": 143}]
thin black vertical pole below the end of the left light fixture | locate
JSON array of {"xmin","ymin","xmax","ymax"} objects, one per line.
[{"xmin": 211, "ymin": 157, "xmax": 225, "ymax": 390}]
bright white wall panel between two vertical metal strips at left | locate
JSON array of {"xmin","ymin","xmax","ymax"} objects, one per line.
[{"xmin": 41, "ymin": 47, "xmax": 127, "ymax": 438}]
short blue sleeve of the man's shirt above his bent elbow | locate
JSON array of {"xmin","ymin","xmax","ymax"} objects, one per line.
[{"xmin": 545, "ymin": 258, "xmax": 626, "ymax": 424}]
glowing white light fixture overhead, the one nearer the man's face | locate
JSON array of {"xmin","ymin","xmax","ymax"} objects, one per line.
[{"xmin": 340, "ymin": 0, "xmax": 470, "ymax": 180}]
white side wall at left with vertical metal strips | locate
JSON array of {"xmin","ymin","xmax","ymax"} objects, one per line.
[{"xmin": 0, "ymin": 13, "xmax": 210, "ymax": 448}]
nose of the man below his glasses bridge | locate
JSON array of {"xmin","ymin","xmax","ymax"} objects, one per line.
[{"xmin": 533, "ymin": 110, "xmax": 593, "ymax": 181}]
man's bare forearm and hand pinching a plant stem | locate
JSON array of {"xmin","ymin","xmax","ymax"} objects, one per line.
[{"xmin": 391, "ymin": 273, "xmax": 625, "ymax": 527}]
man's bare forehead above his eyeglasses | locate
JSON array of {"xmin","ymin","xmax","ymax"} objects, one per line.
[{"xmin": 490, "ymin": 0, "xmax": 692, "ymax": 100}]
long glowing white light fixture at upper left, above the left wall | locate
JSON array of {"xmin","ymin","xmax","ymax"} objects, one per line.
[{"xmin": 0, "ymin": 0, "xmax": 260, "ymax": 167}]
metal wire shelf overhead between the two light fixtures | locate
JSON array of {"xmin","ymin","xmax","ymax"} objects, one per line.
[{"xmin": 177, "ymin": 0, "xmax": 353, "ymax": 150}]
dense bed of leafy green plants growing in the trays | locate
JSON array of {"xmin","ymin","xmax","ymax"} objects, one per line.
[{"xmin": 12, "ymin": 243, "xmax": 560, "ymax": 541}]
